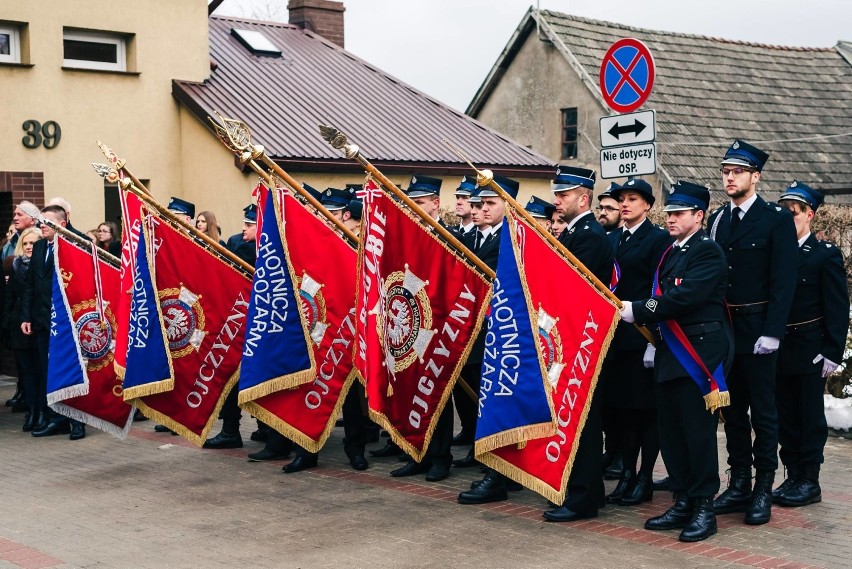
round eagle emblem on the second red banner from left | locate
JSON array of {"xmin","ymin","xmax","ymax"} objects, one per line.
[{"xmin": 159, "ymin": 285, "xmax": 207, "ymax": 358}]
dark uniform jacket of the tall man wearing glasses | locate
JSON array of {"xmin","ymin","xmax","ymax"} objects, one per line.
[{"xmin": 707, "ymin": 196, "xmax": 798, "ymax": 354}]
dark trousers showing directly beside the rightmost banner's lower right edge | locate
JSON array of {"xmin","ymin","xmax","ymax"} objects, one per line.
[{"xmin": 563, "ymin": 393, "xmax": 605, "ymax": 514}]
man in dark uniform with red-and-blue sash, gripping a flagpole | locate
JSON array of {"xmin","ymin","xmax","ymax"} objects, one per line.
[{"xmin": 621, "ymin": 182, "xmax": 733, "ymax": 541}]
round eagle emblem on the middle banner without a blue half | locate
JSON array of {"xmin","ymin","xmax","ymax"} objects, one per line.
[{"xmin": 377, "ymin": 266, "xmax": 438, "ymax": 374}]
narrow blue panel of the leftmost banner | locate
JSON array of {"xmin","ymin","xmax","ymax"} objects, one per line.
[{"xmin": 47, "ymin": 247, "xmax": 89, "ymax": 404}]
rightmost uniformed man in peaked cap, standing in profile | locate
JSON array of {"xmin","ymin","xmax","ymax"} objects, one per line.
[{"xmin": 772, "ymin": 181, "xmax": 849, "ymax": 507}]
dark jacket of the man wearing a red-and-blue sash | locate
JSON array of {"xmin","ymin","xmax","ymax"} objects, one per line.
[{"xmin": 632, "ymin": 230, "xmax": 733, "ymax": 382}]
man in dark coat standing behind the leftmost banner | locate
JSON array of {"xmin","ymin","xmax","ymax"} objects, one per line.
[{"xmin": 21, "ymin": 205, "xmax": 86, "ymax": 441}]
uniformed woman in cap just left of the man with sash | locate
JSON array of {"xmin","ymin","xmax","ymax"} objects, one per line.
[{"xmin": 598, "ymin": 179, "xmax": 672, "ymax": 506}]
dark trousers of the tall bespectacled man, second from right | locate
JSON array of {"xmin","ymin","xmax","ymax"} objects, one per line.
[{"xmin": 722, "ymin": 351, "xmax": 778, "ymax": 472}]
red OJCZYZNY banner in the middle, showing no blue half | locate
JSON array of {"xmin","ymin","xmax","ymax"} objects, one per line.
[{"xmin": 353, "ymin": 180, "xmax": 490, "ymax": 462}]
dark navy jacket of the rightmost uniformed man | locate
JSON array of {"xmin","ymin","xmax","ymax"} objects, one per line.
[{"xmin": 778, "ymin": 234, "xmax": 849, "ymax": 375}]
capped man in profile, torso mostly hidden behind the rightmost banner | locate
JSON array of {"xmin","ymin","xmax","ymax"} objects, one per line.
[{"xmin": 544, "ymin": 166, "xmax": 613, "ymax": 522}]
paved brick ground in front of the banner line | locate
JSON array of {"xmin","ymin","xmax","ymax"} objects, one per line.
[{"xmin": 0, "ymin": 382, "xmax": 852, "ymax": 569}]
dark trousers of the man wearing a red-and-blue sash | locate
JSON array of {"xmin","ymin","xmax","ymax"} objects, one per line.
[{"xmin": 654, "ymin": 377, "xmax": 719, "ymax": 498}]
